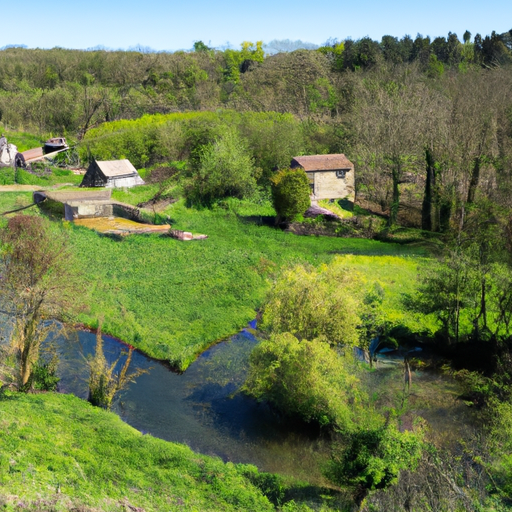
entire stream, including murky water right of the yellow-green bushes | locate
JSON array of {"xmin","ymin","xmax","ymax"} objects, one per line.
[{"xmin": 30, "ymin": 325, "xmax": 478, "ymax": 485}]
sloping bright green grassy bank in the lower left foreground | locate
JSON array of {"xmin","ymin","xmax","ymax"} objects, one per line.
[{"xmin": 0, "ymin": 393, "xmax": 274, "ymax": 512}]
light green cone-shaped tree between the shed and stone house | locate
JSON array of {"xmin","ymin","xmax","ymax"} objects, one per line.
[{"xmin": 185, "ymin": 128, "xmax": 256, "ymax": 204}]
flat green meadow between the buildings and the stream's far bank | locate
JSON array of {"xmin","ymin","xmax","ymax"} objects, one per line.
[{"xmin": 65, "ymin": 198, "xmax": 430, "ymax": 369}]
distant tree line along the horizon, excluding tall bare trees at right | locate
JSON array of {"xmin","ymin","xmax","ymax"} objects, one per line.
[{"xmin": 0, "ymin": 31, "xmax": 512, "ymax": 138}]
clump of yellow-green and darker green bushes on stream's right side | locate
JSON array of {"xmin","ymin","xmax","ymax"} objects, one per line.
[{"xmin": 243, "ymin": 261, "xmax": 423, "ymax": 506}]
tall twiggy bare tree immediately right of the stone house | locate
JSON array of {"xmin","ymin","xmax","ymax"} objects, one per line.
[{"xmin": 350, "ymin": 65, "xmax": 435, "ymax": 225}]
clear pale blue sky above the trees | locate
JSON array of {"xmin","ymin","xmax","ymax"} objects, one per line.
[{"xmin": 0, "ymin": 0, "xmax": 512, "ymax": 51}]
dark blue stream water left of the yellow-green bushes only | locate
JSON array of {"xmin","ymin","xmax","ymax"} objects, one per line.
[{"xmin": 54, "ymin": 330, "xmax": 328, "ymax": 483}]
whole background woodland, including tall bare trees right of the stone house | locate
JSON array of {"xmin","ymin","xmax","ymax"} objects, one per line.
[{"xmin": 0, "ymin": 32, "xmax": 512, "ymax": 226}]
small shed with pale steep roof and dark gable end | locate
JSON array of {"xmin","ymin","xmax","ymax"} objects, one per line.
[{"xmin": 80, "ymin": 159, "xmax": 144, "ymax": 188}]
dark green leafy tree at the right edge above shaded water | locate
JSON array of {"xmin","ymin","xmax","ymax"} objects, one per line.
[{"xmin": 411, "ymin": 202, "xmax": 512, "ymax": 343}]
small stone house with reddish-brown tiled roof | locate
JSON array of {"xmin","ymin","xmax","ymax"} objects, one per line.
[{"xmin": 290, "ymin": 154, "xmax": 355, "ymax": 203}]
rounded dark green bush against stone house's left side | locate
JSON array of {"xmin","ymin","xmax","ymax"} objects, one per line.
[{"xmin": 270, "ymin": 169, "xmax": 311, "ymax": 222}]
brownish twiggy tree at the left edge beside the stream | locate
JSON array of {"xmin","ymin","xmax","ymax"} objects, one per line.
[{"xmin": 0, "ymin": 215, "xmax": 80, "ymax": 391}]
